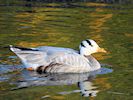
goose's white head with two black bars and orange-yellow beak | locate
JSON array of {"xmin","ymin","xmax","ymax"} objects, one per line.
[{"xmin": 79, "ymin": 39, "xmax": 106, "ymax": 56}]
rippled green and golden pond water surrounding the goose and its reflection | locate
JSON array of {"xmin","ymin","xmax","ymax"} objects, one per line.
[{"xmin": 0, "ymin": 0, "xmax": 133, "ymax": 100}]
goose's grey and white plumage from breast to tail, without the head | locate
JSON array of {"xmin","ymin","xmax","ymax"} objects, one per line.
[{"xmin": 11, "ymin": 46, "xmax": 100, "ymax": 73}]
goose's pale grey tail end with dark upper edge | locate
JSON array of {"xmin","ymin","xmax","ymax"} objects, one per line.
[{"xmin": 9, "ymin": 45, "xmax": 46, "ymax": 69}]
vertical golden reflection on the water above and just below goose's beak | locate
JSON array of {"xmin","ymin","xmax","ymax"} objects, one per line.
[{"xmin": 87, "ymin": 3, "xmax": 113, "ymax": 60}]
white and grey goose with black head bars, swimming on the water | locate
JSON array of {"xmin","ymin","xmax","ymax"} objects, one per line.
[{"xmin": 10, "ymin": 39, "xmax": 106, "ymax": 73}]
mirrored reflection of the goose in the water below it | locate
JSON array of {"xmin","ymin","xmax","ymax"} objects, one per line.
[{"xmin": 12, "ymin": 68, "xmax": 112, "ymax": 97}]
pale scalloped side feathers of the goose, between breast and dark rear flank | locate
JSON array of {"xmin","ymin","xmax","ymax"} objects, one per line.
[{"xmin": 44, "ymin": 53, "xmax": 90, "ymax": 72}]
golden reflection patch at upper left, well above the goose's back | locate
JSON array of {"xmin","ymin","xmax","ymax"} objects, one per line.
[{"xmin": 15, "ymin": 8, "xmax": 59, "ymax": 30}]
